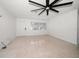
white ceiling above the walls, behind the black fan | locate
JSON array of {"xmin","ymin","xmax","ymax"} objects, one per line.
[{"xmin": 0, "ymin": 0, "xmax": 78, "ymax": 19}]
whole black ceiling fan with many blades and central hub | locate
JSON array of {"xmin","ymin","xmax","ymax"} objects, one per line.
[{"xmin": 29, "ymin": 0, "xmax": 73, "ymax": 16}]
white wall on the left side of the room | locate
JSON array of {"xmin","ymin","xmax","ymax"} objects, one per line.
[{"xmin": 0, "ymin": 7, "xmax": 16, "ymax": 48}]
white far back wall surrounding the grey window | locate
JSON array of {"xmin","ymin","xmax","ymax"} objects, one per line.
[{"xmin": 16, "ymin": 18, "xmax": 47, "ymax": 36}]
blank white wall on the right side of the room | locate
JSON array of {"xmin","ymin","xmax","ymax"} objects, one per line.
[{"xmin": 48, "ymin": 10, "xmax": 77, "ymax": 44}]
